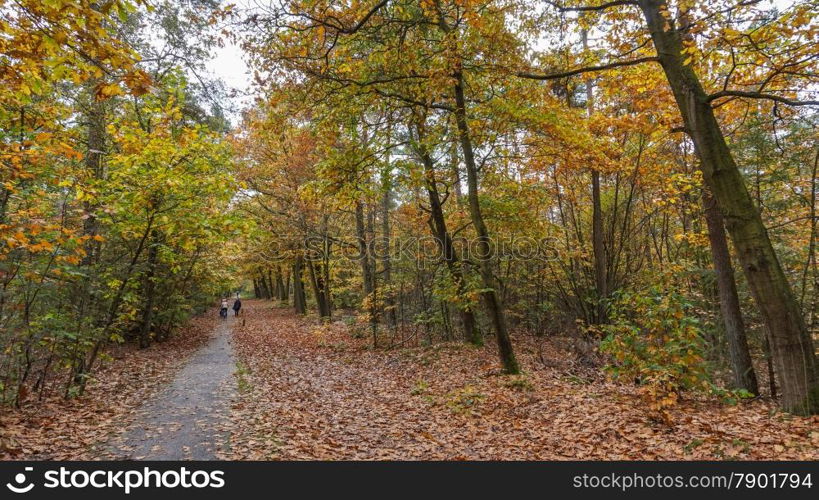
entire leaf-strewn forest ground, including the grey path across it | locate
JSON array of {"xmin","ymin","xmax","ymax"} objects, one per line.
[{"xmin": 0, "ymin": 301, "xmax": 819, "ymax": 460}]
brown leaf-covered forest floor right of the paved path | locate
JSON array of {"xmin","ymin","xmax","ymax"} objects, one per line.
[{"xmin": 221, "ymin": 302, "xmax": 819, "ymax": 460}]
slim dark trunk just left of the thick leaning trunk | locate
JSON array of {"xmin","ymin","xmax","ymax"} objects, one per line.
[{"xmin": 703, "ymin": 191, "xmax": 759, "ymax": 394}]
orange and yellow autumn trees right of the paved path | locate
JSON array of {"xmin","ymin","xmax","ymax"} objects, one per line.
[{"xmin": 235, "ymin": 0, "xmax": 819, "ymax": 419}]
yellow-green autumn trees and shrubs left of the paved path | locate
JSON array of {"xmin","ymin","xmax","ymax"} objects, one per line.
[{"xmin": 0, "ymin": 0, "xmax": 234, "ymax": 406}]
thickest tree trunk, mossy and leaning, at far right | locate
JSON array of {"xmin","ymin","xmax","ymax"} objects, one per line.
[{"xmin": 639, "ymin": 0, "xmax": 819, "ymax": 415}]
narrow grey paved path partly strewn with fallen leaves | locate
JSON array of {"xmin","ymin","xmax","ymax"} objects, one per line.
[{"xmin": 109, "ymin": 315, "xmax": 240, "ymax": 460}]
